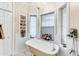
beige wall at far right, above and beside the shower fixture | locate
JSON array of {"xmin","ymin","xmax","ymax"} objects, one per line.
[{"xmin": 70, "ymin": 2, "xmax": 79, "ymax": 52}]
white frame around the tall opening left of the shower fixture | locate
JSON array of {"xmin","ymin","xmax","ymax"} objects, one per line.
[{"xmin": 58, "ymin": 2, "xmax": 70, "ymax": 45}]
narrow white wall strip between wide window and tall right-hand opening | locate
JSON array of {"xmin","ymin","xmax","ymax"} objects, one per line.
[{"xmin": 55, "ymin": 2, "xmax": 67, "ymax": 55}]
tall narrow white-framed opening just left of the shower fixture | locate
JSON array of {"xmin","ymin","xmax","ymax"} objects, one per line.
[{"xmin": 59, "ymin": 3, "xmax": 72, "ymax": 55}]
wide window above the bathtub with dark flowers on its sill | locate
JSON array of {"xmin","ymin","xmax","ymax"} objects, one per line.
[{"xmin": 41, "ymin": 12, "xmax": 55, "ymax": 40}]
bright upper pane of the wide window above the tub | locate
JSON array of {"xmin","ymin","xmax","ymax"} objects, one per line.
[{"xmin": 42, "ymin": 12, "xmax": 55, "ymax": 26}]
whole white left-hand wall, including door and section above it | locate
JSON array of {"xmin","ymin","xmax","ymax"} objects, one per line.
[{"xmin": 0, "ymin": 2, "xmax": 13, "ymax": 55}]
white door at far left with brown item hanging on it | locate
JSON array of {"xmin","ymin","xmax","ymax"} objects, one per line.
[{"xmin": 0, "ymin": 10, "xmax": 12, "ymax": 55}]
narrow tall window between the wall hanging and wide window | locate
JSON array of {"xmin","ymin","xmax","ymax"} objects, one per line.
[{"xmin": 30, "ymin": 15, "xmax": 37, "ymax": 38}]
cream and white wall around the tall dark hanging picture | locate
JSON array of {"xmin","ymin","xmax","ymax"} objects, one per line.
[{"xmin": 14, "ymin": 2, "xmax": 28, "ymax": 54}]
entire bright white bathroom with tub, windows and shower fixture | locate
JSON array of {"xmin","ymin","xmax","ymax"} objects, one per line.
[{"xmin": 0, "ymin": 2, "xmax": 79, "ymax": 56}]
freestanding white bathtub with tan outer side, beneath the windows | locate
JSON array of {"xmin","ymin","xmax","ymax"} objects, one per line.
[{"xmin": 26, "ymin": 38, "xmax": 59, "ymax": 56}]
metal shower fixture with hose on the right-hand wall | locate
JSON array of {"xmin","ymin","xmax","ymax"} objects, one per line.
[{"xmin": 68, "ymin": 28, "xmax": 78, "ymax": 56}]
